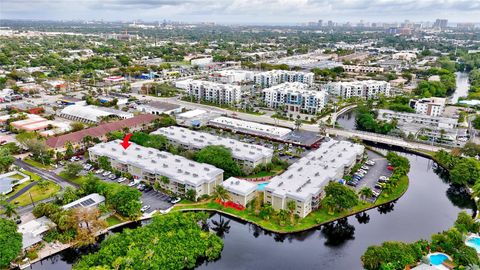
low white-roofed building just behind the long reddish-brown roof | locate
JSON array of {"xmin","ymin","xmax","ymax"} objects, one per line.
[{"xmin": 59, "ymin": 105, "xmax": 133, "ymax": 124}]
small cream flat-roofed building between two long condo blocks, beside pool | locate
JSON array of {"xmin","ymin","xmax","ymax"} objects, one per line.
[{"xmin": 222, "ymin": 177, "xmax": 257, "ymax": 206}]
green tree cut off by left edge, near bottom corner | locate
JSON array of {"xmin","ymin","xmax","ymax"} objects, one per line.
[{"xmin": 0, "ymin": 218, "xmax": 22, "ymax": 269}]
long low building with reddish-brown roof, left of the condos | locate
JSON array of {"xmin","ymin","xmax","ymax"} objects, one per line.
[{"xmin": 46, "ymin": 114, "xmax": 158, "ymax": 151}]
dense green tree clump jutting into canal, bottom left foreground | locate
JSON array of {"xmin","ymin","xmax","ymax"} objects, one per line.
[{"xmin": 74, "ymin": 213, "xmax": 223, "ymax": 270}]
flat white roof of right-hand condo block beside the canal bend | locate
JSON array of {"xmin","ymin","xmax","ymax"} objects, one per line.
[{"xmin": 265, "ymin": 140, "xmax": 364, "ymax": 201}]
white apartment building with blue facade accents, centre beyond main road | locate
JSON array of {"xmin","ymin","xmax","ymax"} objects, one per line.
[{"xmin": 263, "ymin": 82, "xmax": 327, "ymax": 114}]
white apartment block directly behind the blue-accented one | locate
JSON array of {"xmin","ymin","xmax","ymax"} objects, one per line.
[{"xmin": 255, "ymin": 70, "xmax": 314, "ymax": 88}]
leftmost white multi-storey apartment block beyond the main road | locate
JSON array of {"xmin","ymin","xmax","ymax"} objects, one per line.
[{"xmin": 182, "ymin": 80, "xmax": 242, "ymax": 104}]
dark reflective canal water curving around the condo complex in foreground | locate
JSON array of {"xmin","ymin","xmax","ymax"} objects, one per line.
[{"xmin": 32, "ymin": 154, "xmax": 473, "ymax": 270}]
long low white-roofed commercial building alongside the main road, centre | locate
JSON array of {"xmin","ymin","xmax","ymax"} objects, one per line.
[{"xmin": 208, "ymin": 116, "xmax": 292, "ymax": 140}]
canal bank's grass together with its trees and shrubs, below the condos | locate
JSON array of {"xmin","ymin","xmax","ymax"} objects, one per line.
[{"xmin": 173, "ymin": 152, "xmax": 410, "ymax": 233}]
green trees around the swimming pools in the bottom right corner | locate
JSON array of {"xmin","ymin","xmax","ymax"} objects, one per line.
[{"xmin": 361, "ymin": 211, "xmax": 480, "ymax": 270}]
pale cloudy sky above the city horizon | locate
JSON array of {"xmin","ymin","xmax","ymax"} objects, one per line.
[{"xmin": 0, "ymin": 0, "xmax": 480, "ymax": 23}]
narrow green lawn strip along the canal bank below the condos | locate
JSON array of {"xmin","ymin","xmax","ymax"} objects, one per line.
[{"xmin": 173, "ymin": 176, "xmax": 408, "ymax": 233}]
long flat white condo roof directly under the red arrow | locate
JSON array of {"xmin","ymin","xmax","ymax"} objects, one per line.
[{"xmin": 88, "ymin": 140, "xmax": 223, "ymax": 186}]
